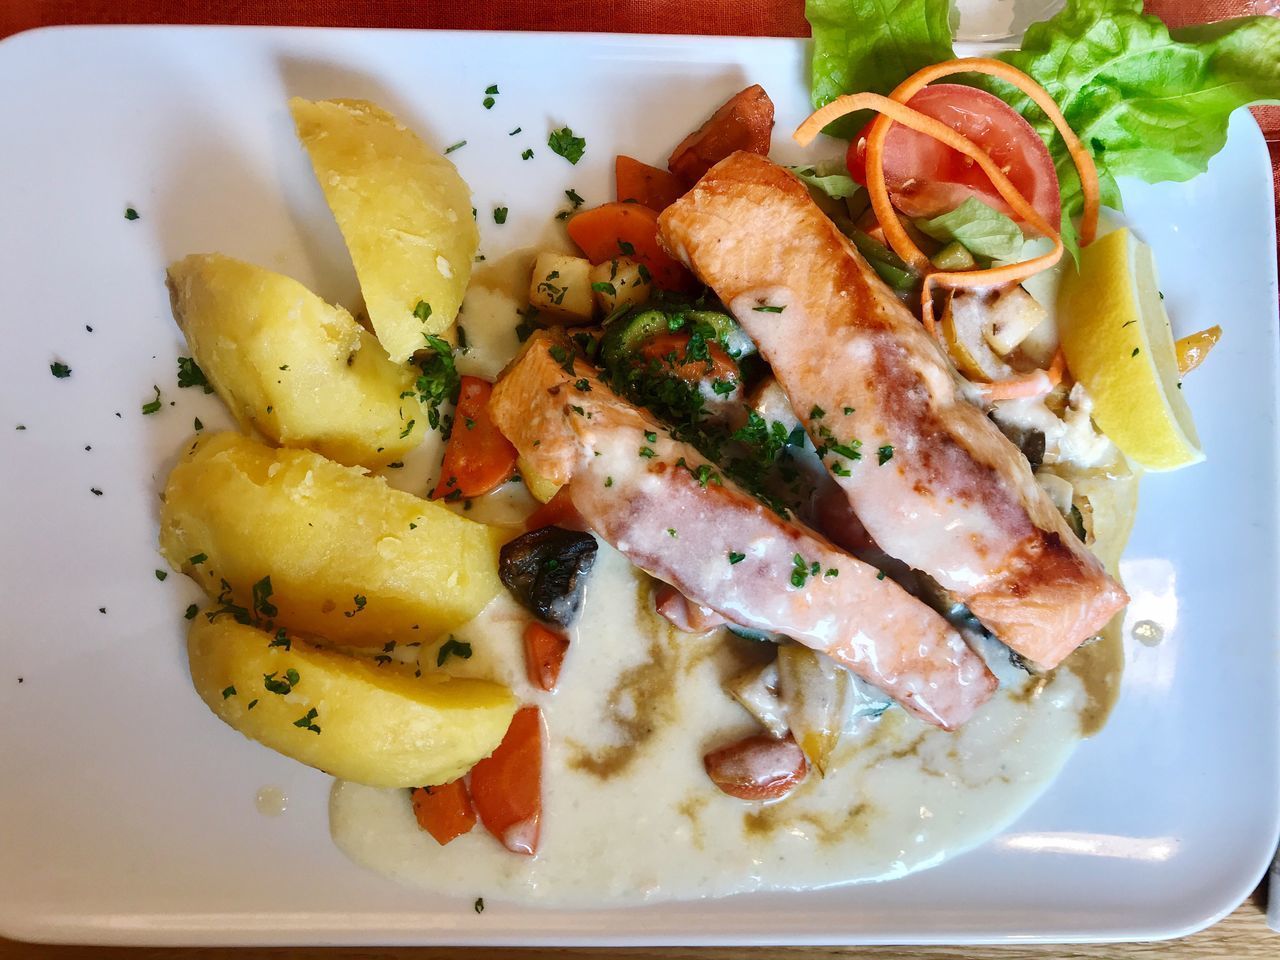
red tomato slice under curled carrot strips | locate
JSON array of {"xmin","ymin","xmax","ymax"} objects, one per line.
[{"xmin": 846, "ymin": 83, "xmax": 1062, "ymax": 230}]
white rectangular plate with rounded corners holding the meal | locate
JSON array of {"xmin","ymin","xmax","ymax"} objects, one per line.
[{"xmin": 0, "ymin": 20, "xmax": 1280, "ymax": 945}]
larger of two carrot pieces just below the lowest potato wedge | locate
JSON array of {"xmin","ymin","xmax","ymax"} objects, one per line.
[{"xmin": 471, "ymin": 707, "xmax": 543, "ymax": 856}]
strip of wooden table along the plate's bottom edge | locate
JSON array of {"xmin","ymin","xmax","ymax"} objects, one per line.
[{"xmin": 0, "ymin": 884, "xmax": 1264, "ymax": 960}]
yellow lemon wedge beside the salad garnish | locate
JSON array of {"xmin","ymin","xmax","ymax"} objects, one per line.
[{"xmin": 1057, "ymin": 229, "xmax": 1204, "ymax": 470}]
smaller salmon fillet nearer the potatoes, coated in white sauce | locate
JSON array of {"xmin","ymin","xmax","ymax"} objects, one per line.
[{"xmin": 489, "ymin": 334, "xmax": 996, "ymax": 730}]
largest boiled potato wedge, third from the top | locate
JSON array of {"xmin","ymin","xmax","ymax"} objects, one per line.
[{"xmin": 160, "ymin": 433, "xmax": 502, "ymax": 646}]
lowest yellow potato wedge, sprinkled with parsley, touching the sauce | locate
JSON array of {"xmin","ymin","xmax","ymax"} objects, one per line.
[{"xmin": 187, "ymin": 614, "xmax": 516, "ymax": 787}]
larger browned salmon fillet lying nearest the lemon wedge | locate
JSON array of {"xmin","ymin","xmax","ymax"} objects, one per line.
[{"xmin": 659, "ymin": 152, "xmax": 1129, "ymax": 668}]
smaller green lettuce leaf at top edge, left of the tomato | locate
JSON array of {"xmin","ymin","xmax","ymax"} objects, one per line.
[{"xmin": 804, "ymin": 0, "xmax": 955, "ymax": 140}]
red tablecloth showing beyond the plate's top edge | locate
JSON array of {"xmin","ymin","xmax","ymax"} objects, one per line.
[{"xmin": 0, "ymin": 0, "xmax": 1280, "ymax": 259}]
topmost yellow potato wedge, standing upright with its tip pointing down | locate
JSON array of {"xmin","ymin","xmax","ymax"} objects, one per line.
[{"xmin": 289, "ymin": 97, "xmax": 480, "ymax": 362}]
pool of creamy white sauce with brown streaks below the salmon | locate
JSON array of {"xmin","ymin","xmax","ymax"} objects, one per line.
[{"xmin": 330, "ymin": 547, "xmax": 1084, "ymax": 906}]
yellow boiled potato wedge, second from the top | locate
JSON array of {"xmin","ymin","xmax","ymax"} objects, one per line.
[{"xmin": 169, "ymin": 253, "xmax": 426, "ymax": 467}]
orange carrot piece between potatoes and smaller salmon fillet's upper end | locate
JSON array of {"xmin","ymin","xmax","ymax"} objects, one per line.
[{"xmin": 431, "ymin": 376, "xmax": 516, "ymax": 499}]
